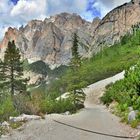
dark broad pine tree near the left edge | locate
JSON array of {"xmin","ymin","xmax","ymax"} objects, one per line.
[{"xmin": 4, "ymin": 41, "xmax": 27, "ymax": 96}]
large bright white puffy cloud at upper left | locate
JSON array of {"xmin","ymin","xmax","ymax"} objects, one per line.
[{"xmin": 10, "ymin": 0, "xmax": 46, "ymax": 22}]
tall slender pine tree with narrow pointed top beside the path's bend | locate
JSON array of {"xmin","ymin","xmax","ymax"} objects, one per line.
[{"xmin": 67, "ymin": 33, "xmax": 85, "ymax": 105}]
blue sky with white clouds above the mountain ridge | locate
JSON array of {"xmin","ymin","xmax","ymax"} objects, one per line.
[{"xmin": 0, "ymin": 0, "xmax": 130, "ymax": 40}]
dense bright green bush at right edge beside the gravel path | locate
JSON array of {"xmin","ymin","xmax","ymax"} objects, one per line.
[{"xmin": 101, "ymin": 62, "xmax": 140, "ymax": 124}]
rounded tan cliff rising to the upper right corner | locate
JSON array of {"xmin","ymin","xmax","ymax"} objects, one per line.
[{"xmin": 92, "ymin": 0, "xmax": 140, "ymax": 53}]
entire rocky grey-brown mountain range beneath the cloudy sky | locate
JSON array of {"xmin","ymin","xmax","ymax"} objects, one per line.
[{"xmin": 0, "ymin": 0, "xmax": 140, "ymax": 69}]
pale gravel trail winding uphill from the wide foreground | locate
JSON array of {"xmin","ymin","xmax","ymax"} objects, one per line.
[{"xmin": 2, "ymin": 72, "xmax": 137, "ymax": 140}]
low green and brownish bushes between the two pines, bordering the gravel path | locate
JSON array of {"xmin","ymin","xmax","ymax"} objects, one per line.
[{"xmin": 10, "ymin": 93, "xmax": 82, "ymax": 115}]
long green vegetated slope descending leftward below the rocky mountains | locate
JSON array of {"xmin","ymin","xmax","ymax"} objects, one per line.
[{"xmin": 46, "ymin": 30, "xmax": 140, "ymax": 95}]
